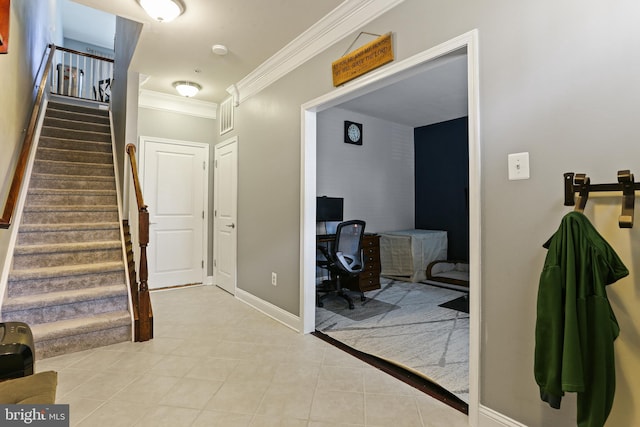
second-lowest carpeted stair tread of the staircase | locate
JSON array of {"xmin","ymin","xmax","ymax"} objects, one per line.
[{"xmin": 2, "ymin": 283, "xmax": 127, "ymax": 313}]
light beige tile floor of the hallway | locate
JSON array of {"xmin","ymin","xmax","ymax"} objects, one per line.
[{"xmin": 36, "ymin": 286, "xmax": 468, "ymax": 427}]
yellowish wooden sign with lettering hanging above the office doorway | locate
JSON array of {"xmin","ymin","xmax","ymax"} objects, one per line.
[{"xmin": 331, "ymin": 33, "xmax": 393, "ymax": 87}]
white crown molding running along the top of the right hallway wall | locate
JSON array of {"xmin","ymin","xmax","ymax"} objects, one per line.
[{"xmin": 227, "ymin": 0, "xmax": 404, "ymax": 105}]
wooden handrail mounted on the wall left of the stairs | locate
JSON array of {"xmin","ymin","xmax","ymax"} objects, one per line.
[{"xmin": 0, "ymin": 44, "xmax": 56, "ymax": 228}]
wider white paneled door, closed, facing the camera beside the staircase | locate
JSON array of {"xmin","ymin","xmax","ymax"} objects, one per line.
[{"xmin": 140, "ymin": 137, "xmax": 209, "ymax": 289}]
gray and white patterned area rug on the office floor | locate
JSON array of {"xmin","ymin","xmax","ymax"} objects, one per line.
[{"xmin": 316, "ymin": 280, "xmax": 469, "ymax": 403}]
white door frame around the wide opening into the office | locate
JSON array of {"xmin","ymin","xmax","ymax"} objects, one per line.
[{"xmin": 300, "ymin": 29, "xmax": 482, "ymax": 425}]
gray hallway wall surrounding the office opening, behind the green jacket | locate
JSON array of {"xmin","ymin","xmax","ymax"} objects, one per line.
[{"xmin": 234, "ymin": 0, "xmax": 640, "ymax": 426}]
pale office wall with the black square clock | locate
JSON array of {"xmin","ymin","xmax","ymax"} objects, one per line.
[{"xmin": 316, "ymin": 108, "xmax": 415, "ymax": 232}]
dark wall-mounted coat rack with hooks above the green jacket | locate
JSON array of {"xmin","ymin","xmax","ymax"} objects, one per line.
[{"xmin": 564, "ymin": 170, "xmax": 640, "ymax": 228}]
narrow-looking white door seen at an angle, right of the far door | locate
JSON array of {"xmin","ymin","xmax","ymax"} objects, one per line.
[{"xmin": 213, "ymin": 137, "xmax": 238, "ymax": 295}]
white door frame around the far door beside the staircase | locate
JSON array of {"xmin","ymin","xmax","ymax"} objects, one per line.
[{"xmin": 138, "ymin": 135, "xmax": 209, "ymax": 285}]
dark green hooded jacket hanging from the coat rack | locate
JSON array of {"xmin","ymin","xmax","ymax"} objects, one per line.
[{"xmin": 534, "ymin": 212, "xmax": 629, "ymax": 427}]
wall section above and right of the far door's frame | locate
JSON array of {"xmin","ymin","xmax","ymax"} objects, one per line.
[{"xmin": 136, "ymin": 108, "xmax": 218, "ymax": 276}]
